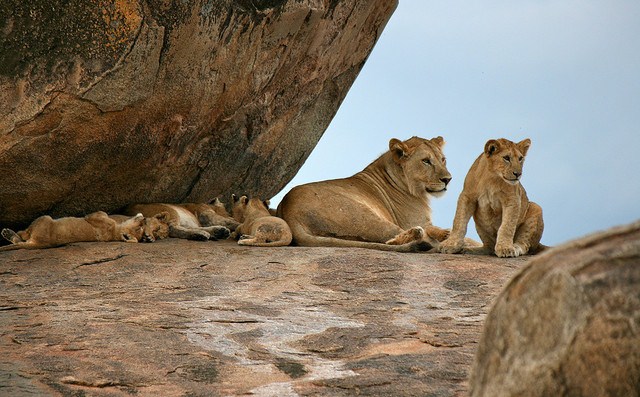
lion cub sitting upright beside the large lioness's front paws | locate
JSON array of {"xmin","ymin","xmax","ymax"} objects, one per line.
[{"xmin": 439, "ymin": 138, "xmax": 544, "ymax": 257}]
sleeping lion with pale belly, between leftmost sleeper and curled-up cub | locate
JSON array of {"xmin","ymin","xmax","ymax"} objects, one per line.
[{"xmin": 124, "ymin": 203, "xmax": 232, "ymax": 240}]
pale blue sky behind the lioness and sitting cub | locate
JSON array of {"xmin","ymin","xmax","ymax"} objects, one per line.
[{"xmin": 272, "ymin": 0, "xmax": 640, "ymax": 245}]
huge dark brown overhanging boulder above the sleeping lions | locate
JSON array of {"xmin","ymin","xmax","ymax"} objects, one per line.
[{"xmin": 0, "ymin": 0, "xmax": 397, "ymax": 228}]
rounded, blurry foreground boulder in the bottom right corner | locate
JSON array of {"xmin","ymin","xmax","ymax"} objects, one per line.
[{"xmin": 470, "ymin": 222, "xmax": 640, "ymax": 397}]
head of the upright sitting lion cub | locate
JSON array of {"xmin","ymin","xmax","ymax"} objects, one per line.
[{"xmin": 484, "ymin": 138, "xmax": 531, "ymax": 185}]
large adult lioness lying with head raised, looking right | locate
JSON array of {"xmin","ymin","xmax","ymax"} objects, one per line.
[{"xmin": 277, "ymin": 137, "xmax": 451, "ymax": 252}]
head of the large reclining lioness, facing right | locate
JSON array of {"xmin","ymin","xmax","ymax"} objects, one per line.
[{"xmin": 389, "ymin": 136, "xmax": 451, "ymax": 196}]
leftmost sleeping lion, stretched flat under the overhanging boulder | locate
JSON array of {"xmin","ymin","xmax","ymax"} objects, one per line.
[{"xmin": 0, "ymin": 211, "xmax": 144, "ymax": 251}]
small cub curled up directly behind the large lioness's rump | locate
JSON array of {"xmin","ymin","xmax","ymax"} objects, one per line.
[{"xmin": 233, "ymin": 195, "xmax": 292, "ymax": 247}]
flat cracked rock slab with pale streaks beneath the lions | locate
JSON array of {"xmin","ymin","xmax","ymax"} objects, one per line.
[{"xmin": 0, "ymin": 239, "xmax": 527, "ymax": 397}]
